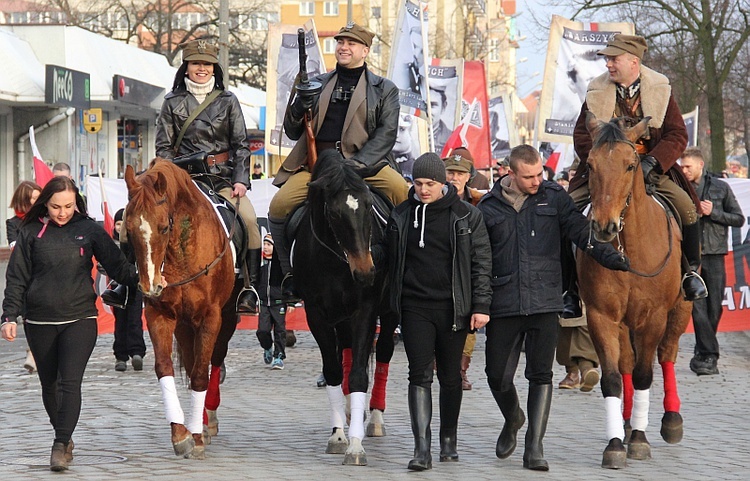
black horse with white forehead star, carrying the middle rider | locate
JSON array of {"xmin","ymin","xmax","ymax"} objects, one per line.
[{"xmin": 293, "ymin": 150, "xmax": 397, "ymax": 466}]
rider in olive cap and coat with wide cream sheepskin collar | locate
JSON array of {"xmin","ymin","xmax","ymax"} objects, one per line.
[{"xmin": 567, "ymin": 34, "xmax": 708, "ymax": 304}]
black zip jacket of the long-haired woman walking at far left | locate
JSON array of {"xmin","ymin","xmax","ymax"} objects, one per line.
[{"xmin": 2, "ymin": 213, "xmax": 138, "ymax": 324}]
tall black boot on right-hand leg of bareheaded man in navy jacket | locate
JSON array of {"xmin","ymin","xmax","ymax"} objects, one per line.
[{"xmin": 523, "ymin": 384, "xmax": 552, "ymax": 471}]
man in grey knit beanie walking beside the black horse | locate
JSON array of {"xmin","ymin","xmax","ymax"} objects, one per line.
[{"xmin": 376, "ymin": 153, "xmax": 492, "ymax": 471}]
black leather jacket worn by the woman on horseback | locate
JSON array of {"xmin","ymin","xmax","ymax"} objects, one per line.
[{"xmin": 156, "ymin": 88, "xmax": 250, "ymax": 188}]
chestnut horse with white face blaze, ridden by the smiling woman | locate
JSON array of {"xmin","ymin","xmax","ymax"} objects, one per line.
[{"xmin": 125, "ymin": 159, "xmax": 237, "ymax": 459}]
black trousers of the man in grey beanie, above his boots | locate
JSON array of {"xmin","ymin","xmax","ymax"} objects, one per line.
[{"xmin": 401, "ymin": 308, "xmax": 468, "ymax": 390}]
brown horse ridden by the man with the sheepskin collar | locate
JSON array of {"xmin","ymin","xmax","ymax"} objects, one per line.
[{"xmin": 577, "ymin": 113, "xmax": 692, "ymax": 469}]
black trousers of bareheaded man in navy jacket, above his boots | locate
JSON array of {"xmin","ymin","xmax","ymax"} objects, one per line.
[{"xmin": 485, "ymin": 312, "xmax": 558, "ymax": 391}]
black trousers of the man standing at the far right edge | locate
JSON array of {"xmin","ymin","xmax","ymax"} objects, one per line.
[{"xmin": 693, "ymin": 254, "xmax": 727, "ymax": 357}]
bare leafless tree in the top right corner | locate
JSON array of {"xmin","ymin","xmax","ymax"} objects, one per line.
[{"xmin": 573, "ymin": 0, "xmax": 750, "ymax": 170}]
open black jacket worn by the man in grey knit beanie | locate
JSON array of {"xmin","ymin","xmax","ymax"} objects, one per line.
[{"xmin": 382, "ymin": 184, "xmax": 492, "ymax": 331}]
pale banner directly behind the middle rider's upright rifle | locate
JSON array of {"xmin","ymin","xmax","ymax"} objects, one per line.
[{"xmin": 266, "ymin": 19, "xmax": 326, "ymax": 156}]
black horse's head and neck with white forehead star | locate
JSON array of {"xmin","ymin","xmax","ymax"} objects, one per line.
[{"xmin": 308, "ymin": 150, "xmax": 375, "ymax": 286}]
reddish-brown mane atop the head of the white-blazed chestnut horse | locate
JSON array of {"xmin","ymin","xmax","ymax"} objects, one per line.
[{"xmin": 129, "ymin": 158, "xmax": 191, "ymax": 210}]
